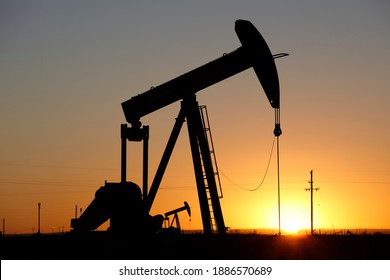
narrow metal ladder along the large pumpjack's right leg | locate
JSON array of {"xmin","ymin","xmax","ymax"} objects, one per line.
[{"xmin": 199, "ymin": 105, "xmax": 223, "ymax": 232}]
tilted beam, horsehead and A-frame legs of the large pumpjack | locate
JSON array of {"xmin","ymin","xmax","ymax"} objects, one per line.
[{"xmin": 122, "ymin": 20, "xmax": 287, "ymax": 234}]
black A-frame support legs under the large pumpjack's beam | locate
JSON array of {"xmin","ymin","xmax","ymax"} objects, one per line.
[{"xmin": 122, "ymin": 95, "xmax": 226, "ymax": 234}]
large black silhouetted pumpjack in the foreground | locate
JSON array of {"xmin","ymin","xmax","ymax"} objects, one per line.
[{"xmin": 71, "ymin": 20, "xmax": 287, "ymax": 234}]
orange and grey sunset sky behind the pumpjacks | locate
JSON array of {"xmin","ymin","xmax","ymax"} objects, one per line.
[{"xmin": 0, "ymin": 0, "xmax": 390, "ymax": 234}]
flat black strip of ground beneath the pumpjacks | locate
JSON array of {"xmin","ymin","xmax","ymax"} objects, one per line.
[{"xmin": 0, "ymin": 232, "xmax": 390, "ymax": 260}]
